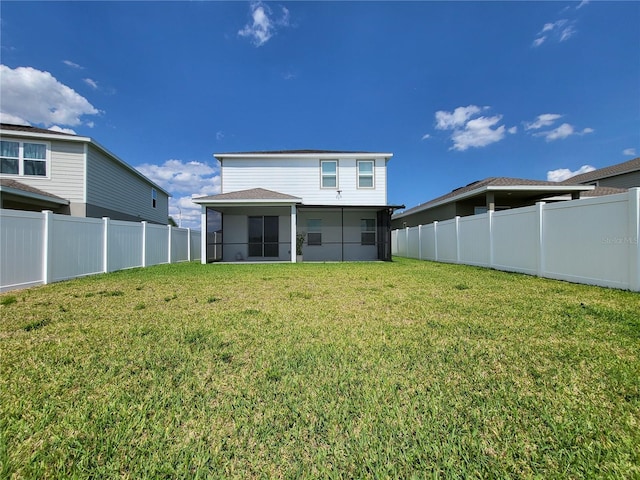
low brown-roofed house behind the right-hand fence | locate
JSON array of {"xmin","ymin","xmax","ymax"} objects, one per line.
[{"xmin": 391, "ymin": 177, "xmax": 596, "ymax": 230}]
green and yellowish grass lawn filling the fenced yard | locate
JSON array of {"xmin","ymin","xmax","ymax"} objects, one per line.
[{"xmin": 0, "ymin": 259, "xmax": 640, "ymax": 479}]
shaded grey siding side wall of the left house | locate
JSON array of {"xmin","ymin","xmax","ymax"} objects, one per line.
[{"xmin": 86, "ymin": 145, "xmax": 169, "ymax": 225}]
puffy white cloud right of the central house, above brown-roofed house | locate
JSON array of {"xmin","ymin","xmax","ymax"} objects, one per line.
[{"xmin": 432, "ymin": 105, "xmax": 508, "ymax": 152}]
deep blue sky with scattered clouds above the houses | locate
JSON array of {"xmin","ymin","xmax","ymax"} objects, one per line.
[{"xmin": 0, "ymin": 1, "xmax": 640, "ymax": 226}]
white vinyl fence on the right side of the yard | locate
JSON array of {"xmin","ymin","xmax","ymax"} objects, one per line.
[{"xmin": 391, "ymin": 188, "xmax": 640, "ymax": 291}]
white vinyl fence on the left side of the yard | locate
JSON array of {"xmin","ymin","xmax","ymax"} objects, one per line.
[{"xmin": 0, "ymin": 210, "xmax": 200, "ymax": 292}]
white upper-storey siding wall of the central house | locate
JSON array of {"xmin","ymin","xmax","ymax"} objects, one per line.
[{"xmin": 221, "ymin": 155, "xmax": 387, "ymax": 205}]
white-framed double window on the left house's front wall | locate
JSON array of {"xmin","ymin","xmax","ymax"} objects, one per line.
[{"xmin": 0, "ymin": 140, "xmax": 49, "ymax": 177}]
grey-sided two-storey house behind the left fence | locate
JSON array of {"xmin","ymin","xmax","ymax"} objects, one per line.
[{"xmin": 0, "ymin": 123, "xmax": 170, "ymax": 225}]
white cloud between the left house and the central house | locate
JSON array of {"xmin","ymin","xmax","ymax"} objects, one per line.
[{"xmin": 136, "ymin": 160, "xmax": 220, "ymax": 228}]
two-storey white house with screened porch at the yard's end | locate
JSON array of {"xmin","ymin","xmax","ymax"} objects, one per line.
[{"xmin": 193, "ymin": 150, "xmax": 404, "ymax": 263}]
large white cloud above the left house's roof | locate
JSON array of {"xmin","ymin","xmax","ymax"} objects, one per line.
[{"xmin": 0, "ymin": 65, "xmax": 100, "ymax": 127}]
